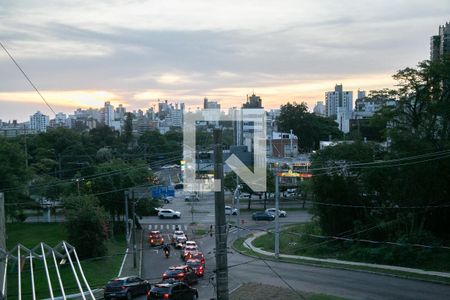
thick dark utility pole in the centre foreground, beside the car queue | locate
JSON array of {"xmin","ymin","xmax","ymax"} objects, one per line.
[{"xmin": 214, "ymin": 129, "xmax": 228, "ymax": 300}]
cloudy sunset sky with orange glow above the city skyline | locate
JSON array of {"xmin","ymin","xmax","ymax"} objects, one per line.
[{"xmin": 0, "ymin": 0, "xmax": 450, "ymax": 121}]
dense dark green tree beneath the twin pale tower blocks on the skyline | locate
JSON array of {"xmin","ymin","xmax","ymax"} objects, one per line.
[{"xmin": 277, "ymin": 102, "xmax": 342, "ymax": 151}]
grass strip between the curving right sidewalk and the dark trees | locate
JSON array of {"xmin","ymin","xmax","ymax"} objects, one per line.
[{"xmin": 253, "ymin": 223, "xmax": 450, "ymax": 272}]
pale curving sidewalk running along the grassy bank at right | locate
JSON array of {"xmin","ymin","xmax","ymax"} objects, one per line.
[{"xmin": 244, "ymin": 232, "xmax": 450, "ymax": 278}]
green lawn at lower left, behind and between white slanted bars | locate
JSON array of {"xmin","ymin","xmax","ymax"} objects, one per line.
[{"xmin": 6, "ymin": 223, "xmax": 125, "ymax": 299}]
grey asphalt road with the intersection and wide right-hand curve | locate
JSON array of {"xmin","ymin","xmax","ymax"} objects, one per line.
[{"xmin": 141, "ymin": 194, "xmax": 450, "ymax": 299}]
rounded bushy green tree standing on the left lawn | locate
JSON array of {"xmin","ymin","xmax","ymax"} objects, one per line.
[{"xmin": 64, "ymin": 196, "xmax": 109, "ymax": 258}]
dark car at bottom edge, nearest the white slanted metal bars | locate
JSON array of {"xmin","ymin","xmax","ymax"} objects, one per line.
[{"xmin": 103, "ymin": 276, "xmax": 151, "ymax": 300}]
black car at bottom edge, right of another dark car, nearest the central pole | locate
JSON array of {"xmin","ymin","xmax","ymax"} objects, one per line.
[{"xmin": 147, "ymin": 282, "xmax": 198, "ymax": 300}]
